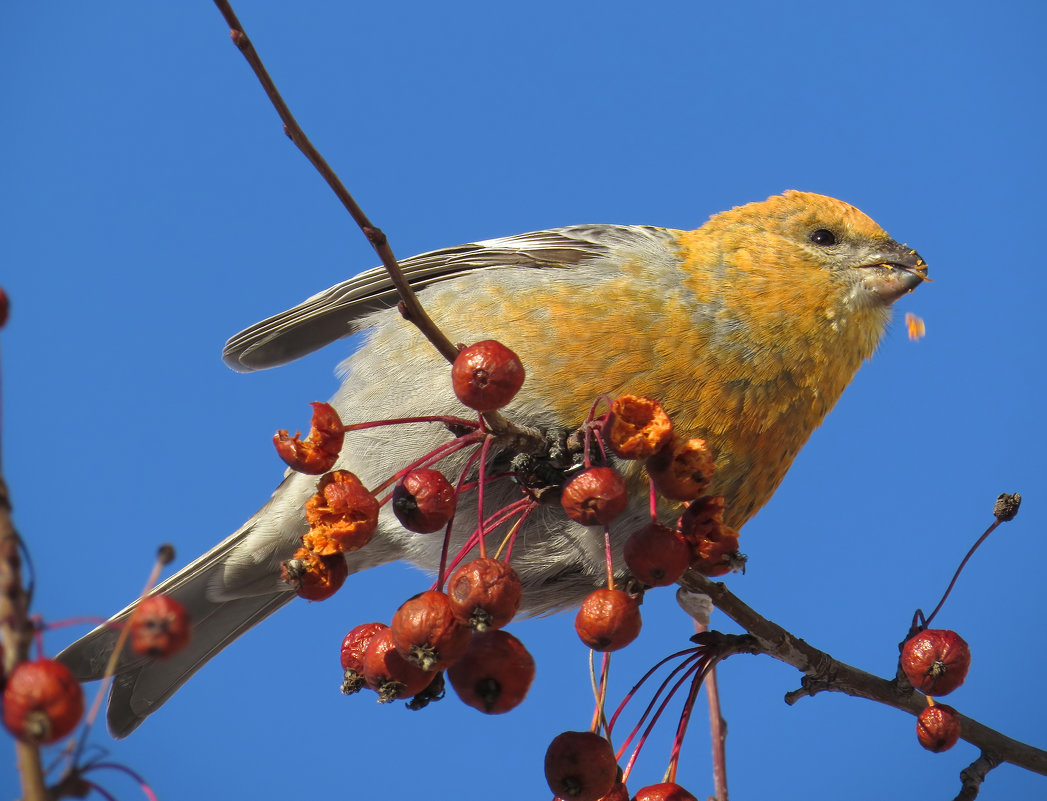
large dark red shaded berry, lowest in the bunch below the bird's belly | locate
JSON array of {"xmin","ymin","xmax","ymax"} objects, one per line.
[{"xmin": 447, "ymin": 629, "xmax": 534, "ymax": 715}]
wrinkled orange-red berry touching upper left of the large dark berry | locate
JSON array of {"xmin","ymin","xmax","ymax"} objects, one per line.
[{"xmin": 391, "ymin": 589, "xmax": 472, "ymax": 671}]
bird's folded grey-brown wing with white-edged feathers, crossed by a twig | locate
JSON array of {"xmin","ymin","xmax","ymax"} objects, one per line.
[{"xmin": 222, "ymin": 225, "xmax": 665, "ymax": 373}]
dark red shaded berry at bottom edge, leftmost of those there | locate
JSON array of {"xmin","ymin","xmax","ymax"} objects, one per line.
[{"xmin": 545, "ymin": 732, "xmax": 620, "ymax": 801}]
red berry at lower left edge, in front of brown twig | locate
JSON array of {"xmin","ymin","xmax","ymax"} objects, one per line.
[{"xmin": 3, "ymin": 660, "xmax": 84, "ymax": 744}]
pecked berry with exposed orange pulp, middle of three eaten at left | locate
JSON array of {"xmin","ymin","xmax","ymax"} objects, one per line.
[{"xmin": 302, "ymin": 470, "xmax": 378, "ymax": 556}]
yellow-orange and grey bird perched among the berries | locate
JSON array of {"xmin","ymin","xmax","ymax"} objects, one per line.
[{"xmin": 58, "ymin": 190, "xmax": 928, "ymax": 737}]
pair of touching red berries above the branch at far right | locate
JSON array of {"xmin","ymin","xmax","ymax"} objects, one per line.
[{"xmin": 901, "ymin": 628, "xmax": 971, "ymax": 753}]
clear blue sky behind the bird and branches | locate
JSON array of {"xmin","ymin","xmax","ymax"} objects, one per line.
[{"xmin": 0, "ymin": 0, "xmax": 1047, "ymax": 801}]
